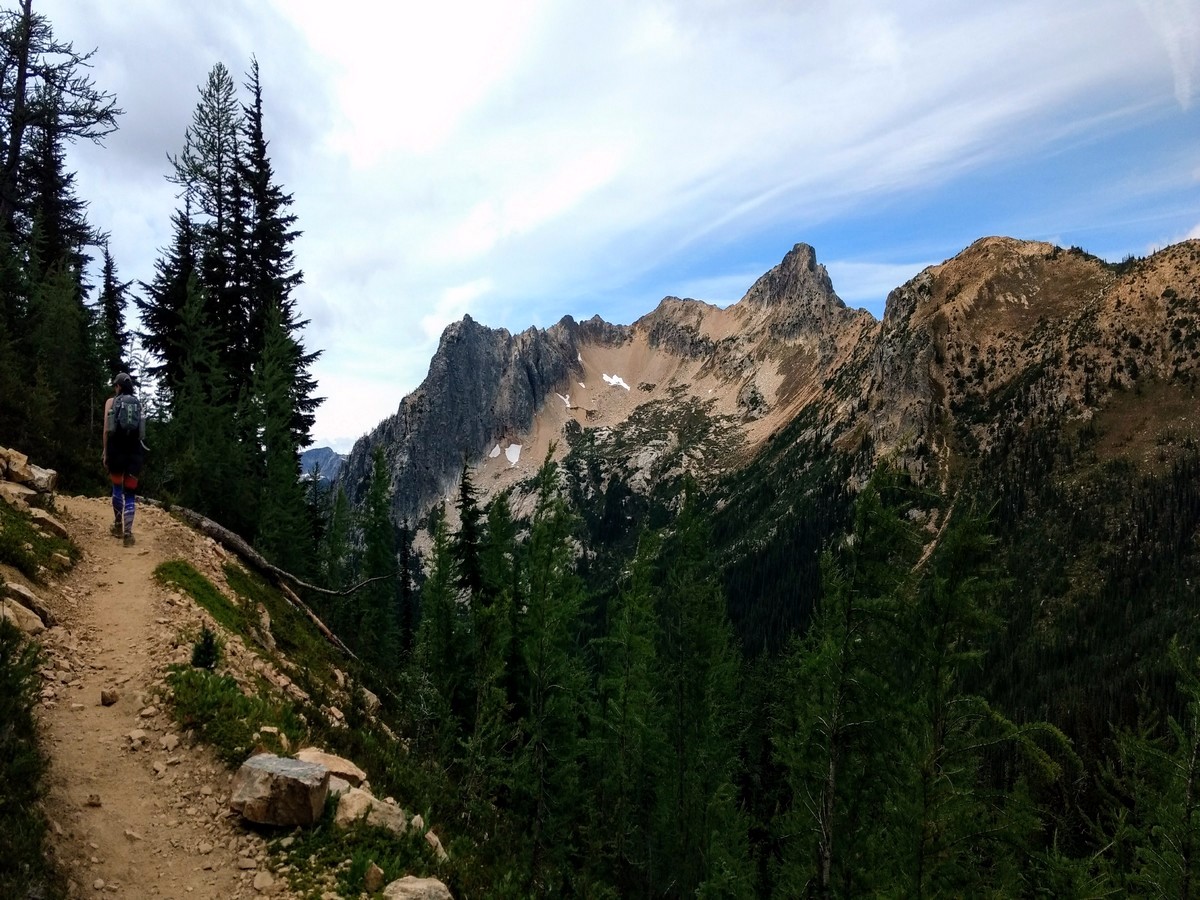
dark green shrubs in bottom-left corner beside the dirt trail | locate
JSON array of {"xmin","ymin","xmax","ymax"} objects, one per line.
[{"xmin": 0, "ymin": 620, "xmax": 66, "ymax": 898}]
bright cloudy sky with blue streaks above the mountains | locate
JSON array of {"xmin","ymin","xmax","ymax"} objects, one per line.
[{"xmin": 35, "ymin": 0, "xmax": 1200, "ymax": 450}]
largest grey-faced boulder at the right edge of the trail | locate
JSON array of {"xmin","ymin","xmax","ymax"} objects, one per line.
[{"xmin": 229, "ymin": 754, "xmax": 329, "ymax": 826}]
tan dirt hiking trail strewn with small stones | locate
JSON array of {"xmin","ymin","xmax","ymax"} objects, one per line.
[{"xmin": 40, "ymin": 497, "xmax": 302, "ymax": 900}]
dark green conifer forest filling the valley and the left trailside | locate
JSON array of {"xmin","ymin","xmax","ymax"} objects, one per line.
[{"xmin": 0, "ymin": 0, "xmax": 1200, "ymax": 898}]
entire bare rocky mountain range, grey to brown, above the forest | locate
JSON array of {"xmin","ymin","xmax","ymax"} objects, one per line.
[{"xmin": 343, "ymin": 238, "xmax": 1200, "ymax": 532}]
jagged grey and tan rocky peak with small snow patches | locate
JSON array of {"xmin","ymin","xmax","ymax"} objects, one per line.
[{"xmin": 343, "ymin": 245, "xmax": 877, "ymax": 522}]
